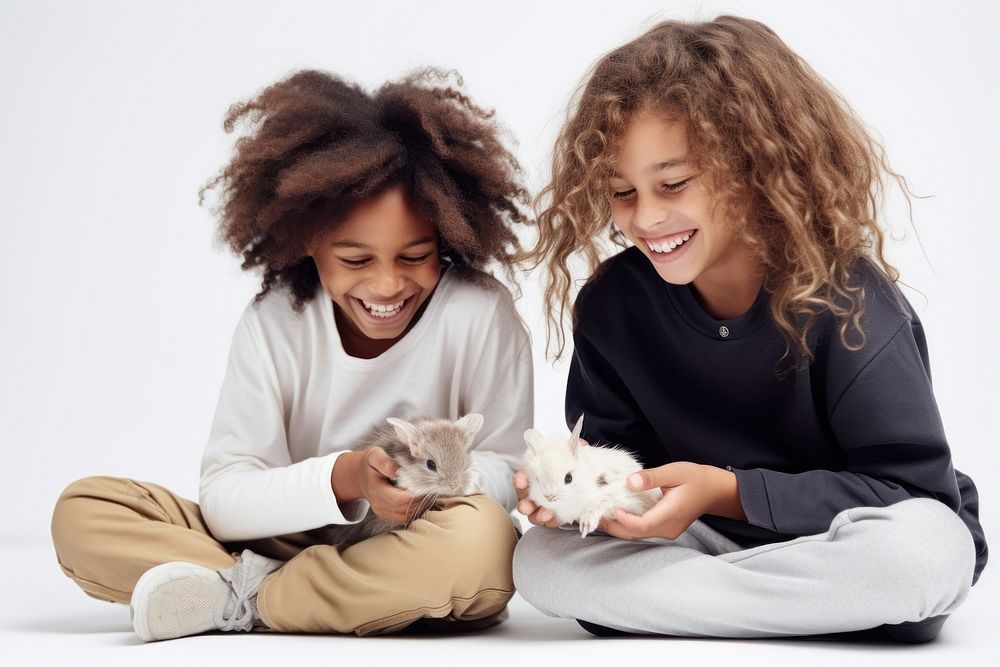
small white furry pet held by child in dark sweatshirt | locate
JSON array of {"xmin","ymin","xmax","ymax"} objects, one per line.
[{"xmin": 523, "ymin": 416, "xmax": 663, "ymax": 537}]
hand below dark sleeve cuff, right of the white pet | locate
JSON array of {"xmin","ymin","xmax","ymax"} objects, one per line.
[{"xmin": 599, "ymin": 461, "xmax": 746, "ymax": 540}]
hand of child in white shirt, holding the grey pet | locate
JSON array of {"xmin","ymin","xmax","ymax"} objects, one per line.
[{"xmin": 333, "ymin": 447, "xmax": 425, "ymax": 524}]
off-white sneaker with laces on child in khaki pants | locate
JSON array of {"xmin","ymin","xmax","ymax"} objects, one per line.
[{"xmin": 129, "ymin": 549, "xmax": 284, "ymax": 642}]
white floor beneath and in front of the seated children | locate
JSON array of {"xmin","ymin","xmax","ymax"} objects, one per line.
[{"xmin": 0, "ymin": 543, "xmax": 1000, "ymax": 667}]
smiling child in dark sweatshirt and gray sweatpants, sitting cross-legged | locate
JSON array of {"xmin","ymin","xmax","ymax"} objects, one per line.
[{"xmin": 514, "ymin": 16, "xmax": 987, "ymax": 642}]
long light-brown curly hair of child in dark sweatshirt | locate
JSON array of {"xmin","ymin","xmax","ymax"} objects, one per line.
[{"xmin": 522, "ymin": 16, "xmax": 910, "ymax": 363}]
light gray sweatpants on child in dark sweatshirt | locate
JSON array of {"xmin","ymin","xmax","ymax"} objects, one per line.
[{"xmin": 514, "ymin": 498, "xmax": 975, "ymax": 637}]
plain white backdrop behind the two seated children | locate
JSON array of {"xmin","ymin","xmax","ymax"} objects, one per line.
[{"xmin": 0, "ymin": 0, "xmax": 1000, "ymax": 541}]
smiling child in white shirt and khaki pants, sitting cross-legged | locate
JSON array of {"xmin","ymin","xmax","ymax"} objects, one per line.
[{"xmin": 52, "ymin": 70, "xmax": 533, "ymax": 641}]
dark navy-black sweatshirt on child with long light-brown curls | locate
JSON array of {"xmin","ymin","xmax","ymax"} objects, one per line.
[{"xmin": 566, "ymin": 248, "xmax": 987, "ymax": 581}]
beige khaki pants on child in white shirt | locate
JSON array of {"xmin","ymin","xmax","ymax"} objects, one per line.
[{"xmin": 52, "ymin": 477, "xmax": 517, "ymax": 635}]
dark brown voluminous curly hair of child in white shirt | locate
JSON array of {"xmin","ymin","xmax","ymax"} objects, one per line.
[{"xmin": 199, "ymin": 68, "xmax": 528, "ymax": 311}]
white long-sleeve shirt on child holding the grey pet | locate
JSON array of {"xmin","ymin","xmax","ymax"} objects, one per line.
[{"xmin": 200, "ymin": 269, "xmax": 533, "ymax": 541}]
